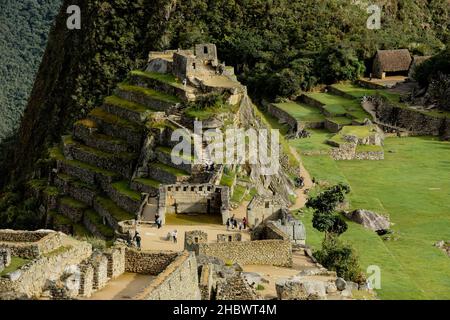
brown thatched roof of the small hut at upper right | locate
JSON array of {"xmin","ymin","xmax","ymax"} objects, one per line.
[{"xmin": 374, "ymin": 49, "xmax": 412, "ymax": 72}]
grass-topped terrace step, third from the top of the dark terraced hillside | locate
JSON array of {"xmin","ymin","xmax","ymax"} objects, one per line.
[{"xmin": 101, "ymin": 95, "xmax": 155, "ymax": 123}]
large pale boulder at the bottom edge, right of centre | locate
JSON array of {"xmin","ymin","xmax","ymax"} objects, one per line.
[{"xmin": 275, "ymin": 277, "xmax": 327, "ymax": 300}]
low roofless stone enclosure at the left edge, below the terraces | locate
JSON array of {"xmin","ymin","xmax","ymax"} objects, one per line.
[{"xmin": 0, "ymin": 230, "xmax": 61, "ymax": 259}]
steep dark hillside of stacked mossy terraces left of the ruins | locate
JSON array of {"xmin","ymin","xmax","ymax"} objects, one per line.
[{"xmin": 29, "ymin": 71, "xmax": 208, "ymax": 239}]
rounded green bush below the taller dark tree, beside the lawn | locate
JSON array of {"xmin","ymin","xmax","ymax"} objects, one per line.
[{"xmin": 314, "ymin": 236, "xmax": 365, "ymax": 283}]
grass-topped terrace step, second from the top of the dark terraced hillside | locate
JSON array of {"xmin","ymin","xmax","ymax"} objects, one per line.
[{"xmin": 115, "ymin": 83, "xmax": 181, "ymax": 111}]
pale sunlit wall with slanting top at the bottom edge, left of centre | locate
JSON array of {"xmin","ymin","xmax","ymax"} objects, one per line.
[{"xmin": 133, "ymin": 251, "xmax": 201, "ymax": 300}]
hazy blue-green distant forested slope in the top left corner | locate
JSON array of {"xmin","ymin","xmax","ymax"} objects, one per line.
[{"xmin": 0, "ymin": 0, "xmax": 62, "ymax": 141}]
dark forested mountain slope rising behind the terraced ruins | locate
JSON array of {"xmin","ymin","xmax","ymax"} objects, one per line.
[{"xmin": 0, "ymin": 0, "xmax": 450, "ymax": 189}]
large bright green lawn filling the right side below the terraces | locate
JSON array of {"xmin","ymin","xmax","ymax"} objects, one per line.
[{"xmin": 298, "ymin": 137, "xmax": 450, "ymax": 299}]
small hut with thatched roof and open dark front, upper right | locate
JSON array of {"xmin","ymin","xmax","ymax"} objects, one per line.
[{"xmin": 372, "ymin": 49, "xmax": 412, "ymax": 79}]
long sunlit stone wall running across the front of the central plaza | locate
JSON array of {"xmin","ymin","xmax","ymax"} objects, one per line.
[{"xmin": 198, "ymin": 240, "xmax": 292, "ymax": 267}]
